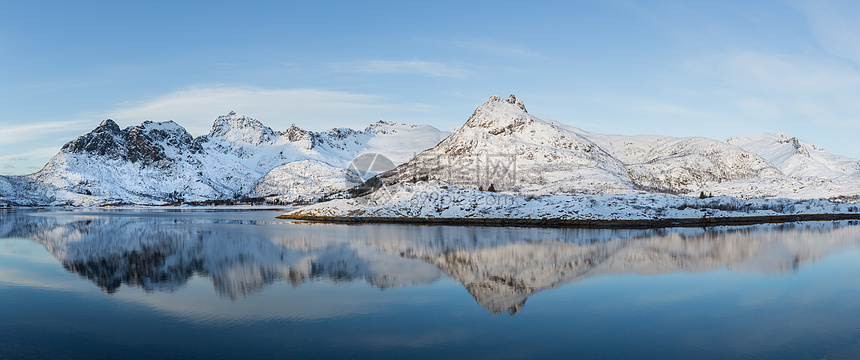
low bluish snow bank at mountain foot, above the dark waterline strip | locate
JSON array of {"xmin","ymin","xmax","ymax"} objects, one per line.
[{"xmin": 285, "ymin": 181, "xmax": 860, "ymax": 221}]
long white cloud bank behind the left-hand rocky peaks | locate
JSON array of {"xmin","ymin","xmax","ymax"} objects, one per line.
[{"xmin": 101, "ymin": 86, "xmax": 434, "ymax": 136}]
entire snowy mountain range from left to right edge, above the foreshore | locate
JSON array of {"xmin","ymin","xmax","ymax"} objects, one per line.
[{"xmin": 0, "ymin": 95, "xmax": 860, "ymax": 206}]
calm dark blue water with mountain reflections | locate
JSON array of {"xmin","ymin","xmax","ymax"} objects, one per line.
[{"xmin": 0, "ymin": 210, "xmax": 860, "ymax": 359}]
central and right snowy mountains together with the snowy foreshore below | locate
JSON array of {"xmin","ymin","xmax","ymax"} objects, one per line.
[{"xmin": 287, "ymin": 95, "xmax": 860, "ymax": 221}]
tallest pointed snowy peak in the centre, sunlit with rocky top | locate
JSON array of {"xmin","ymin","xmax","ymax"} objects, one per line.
[{"xmin": 381, "ymin": 95, "xmax": 635, "ymax": 193}]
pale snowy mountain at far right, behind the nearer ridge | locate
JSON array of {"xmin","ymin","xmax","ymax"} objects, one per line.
[{"xmin": 726, "ymin": 133, "xmax": 860, "ymax": 179}]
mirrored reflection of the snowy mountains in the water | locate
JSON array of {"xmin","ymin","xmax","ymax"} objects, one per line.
[{"xmin": 0, "ymin": 211, "xmax": 860, "ymax": 315}]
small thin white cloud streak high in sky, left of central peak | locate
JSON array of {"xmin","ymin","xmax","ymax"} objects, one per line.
[{"xmin": 334, "ymin": 60, "xmax": 470, "ymax": 78}]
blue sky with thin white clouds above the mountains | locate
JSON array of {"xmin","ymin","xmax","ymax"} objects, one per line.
[{"xmin": 0, "ymin": 0, "xmax": 860, "ymax": 174}]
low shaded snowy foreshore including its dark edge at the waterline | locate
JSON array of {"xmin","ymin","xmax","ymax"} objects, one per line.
[{"xmin": 279, "ymin": 181, "xmax": 860, "ymax": 228}]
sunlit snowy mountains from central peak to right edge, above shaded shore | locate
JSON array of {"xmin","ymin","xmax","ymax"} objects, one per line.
[{"xmin": 380, "ymin": 95, "xmax": 860, "ymax": 199}]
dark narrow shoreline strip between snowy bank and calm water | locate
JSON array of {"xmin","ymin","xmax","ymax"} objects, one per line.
[{"xmin": 277, "ymin": 213, "xmax": 860, "ymax": 229}]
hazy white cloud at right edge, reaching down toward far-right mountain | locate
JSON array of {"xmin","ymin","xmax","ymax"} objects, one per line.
[{"xmin": 685, "ymin": 51, "xmax": 860, "ymax": 156}]
